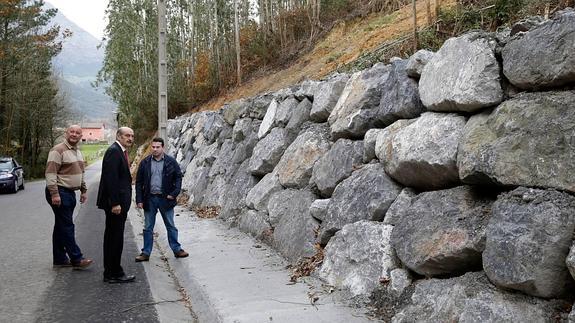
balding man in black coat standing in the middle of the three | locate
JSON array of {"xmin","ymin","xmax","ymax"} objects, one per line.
[{"xmin": 97, "ymin": 127, "xmax": 136, "ymax": 283}]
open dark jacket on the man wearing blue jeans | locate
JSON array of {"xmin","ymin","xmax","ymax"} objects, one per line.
[{"xmin": 136, "ymin": 154, "xmax": 182, "ymax": 210}]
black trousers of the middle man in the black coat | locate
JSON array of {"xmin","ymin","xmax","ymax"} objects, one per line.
[{"xmin": 104, "ymin": 210, "xmax": 128, "ymax": 278}]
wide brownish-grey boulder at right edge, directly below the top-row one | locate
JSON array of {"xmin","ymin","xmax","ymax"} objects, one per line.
[{"xmin": 457, "ymin": 91, "xmax": 575, "ymax": 192}]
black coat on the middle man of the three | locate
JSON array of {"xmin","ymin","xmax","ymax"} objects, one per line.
[{"xmin": 96, "ymin": 142, "xmax": 132, "ymax": 212}]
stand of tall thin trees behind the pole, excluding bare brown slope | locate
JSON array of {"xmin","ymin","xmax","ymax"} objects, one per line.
[{"xmin": 99, "ymin": 0, "xmax": 414, "ymax": 135}]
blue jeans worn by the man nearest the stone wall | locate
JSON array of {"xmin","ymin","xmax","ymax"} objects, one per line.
[{"xmin": 142, "ymin": 195, "xmax": 182, "ymax": 256}]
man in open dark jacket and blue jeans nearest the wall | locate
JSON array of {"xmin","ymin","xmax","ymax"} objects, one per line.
[{"xmin": 136, "ymin": 138, "xmax": 188, "ymax": 262}]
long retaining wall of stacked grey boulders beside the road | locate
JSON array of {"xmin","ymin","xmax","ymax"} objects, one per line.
[{"xmin": 163, "ymin": 10, "xmax": 575, "ymax": 322}]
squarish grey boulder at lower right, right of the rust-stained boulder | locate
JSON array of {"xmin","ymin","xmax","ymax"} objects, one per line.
[{"xmin": 483, "ymin": 187, "xmax": 575, "ymax": 298}]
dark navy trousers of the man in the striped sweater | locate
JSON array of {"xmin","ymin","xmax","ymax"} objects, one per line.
[{"xmin": 45, "ymin": 187, "xmax": 82, "ymax": 265}]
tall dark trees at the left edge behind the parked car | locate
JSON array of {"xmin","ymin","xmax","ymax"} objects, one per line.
[{"xmin": 0, "ymin": 0, "xmax": 68, "ymax": 176}]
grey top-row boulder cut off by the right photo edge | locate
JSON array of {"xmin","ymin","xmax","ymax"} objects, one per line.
[{"xmin": 502, "ymin": 10, "xmax": 575, "ymax": 90}]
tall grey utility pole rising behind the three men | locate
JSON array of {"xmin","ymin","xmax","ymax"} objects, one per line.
[{"xmin": 158, "ymin": 0, "xmax": 168, "ymax": 140}]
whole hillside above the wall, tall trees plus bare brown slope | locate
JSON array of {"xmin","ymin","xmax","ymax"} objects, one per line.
[{"xmin": 99, "ymin": 0, "xmax": 568, "ymax": 140}]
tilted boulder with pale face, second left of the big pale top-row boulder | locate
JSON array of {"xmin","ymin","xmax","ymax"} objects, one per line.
[{"xmin": 328, "ymin": 63, "xmax": 391, "ymax": 140}]
